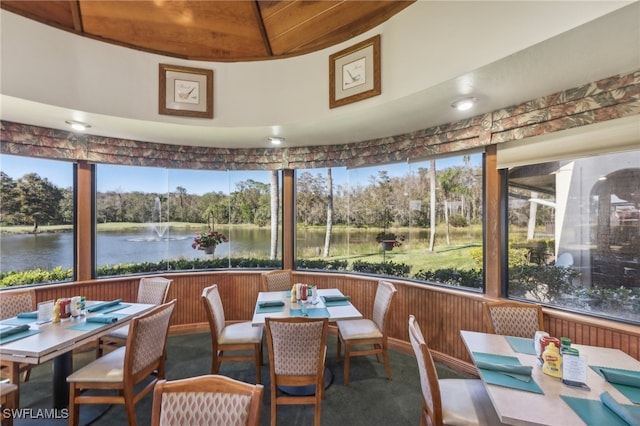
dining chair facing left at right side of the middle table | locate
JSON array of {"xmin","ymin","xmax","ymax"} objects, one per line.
[{"xmin": 337, "ymin": 280, "xmax": 397, "ymax": 386}]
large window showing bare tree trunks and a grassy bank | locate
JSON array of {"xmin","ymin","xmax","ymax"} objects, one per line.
[{"xmin": 296, "ymin": 153, "xmax": 483, "ymax": 289}]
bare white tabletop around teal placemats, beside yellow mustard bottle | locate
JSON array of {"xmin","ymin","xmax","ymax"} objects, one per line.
[{"xmin": 460, "ymin": 331, "xmax": 640, "ymax": 426}]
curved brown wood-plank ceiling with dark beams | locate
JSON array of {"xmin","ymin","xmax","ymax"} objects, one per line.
[{"xmin": 0, "ymin": 0, "xmax": 415, "ymax": 62}]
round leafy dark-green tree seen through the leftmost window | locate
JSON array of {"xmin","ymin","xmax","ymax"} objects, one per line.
[{"xmin": 17, "ymin": 173, "xmax": 62, "ymax": 233}]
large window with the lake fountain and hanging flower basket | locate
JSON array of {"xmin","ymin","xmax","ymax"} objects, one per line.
[{"xmin": 96, "ymin": 165, "xmax": 281, "ymax": 276}]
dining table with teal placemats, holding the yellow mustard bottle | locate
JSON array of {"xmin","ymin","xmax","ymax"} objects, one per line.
[{"xmin": 460, "ymin": 330, "xmax": 640, "ymax": 426}]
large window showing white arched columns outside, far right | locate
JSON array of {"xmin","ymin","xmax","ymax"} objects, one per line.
[{"xmin": 508, "ymin": 151, "xmax": 640, "ymax": 321}]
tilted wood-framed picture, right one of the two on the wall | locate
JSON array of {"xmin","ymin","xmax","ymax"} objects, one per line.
[{"xmin": 329, "ymin": 35, "xmax": 380, "ymax": 108}]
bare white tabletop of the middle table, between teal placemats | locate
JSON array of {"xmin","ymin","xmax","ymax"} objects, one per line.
[{"xmin": 251, "ymin": 288, "xmax": 362, "ymax": 326}]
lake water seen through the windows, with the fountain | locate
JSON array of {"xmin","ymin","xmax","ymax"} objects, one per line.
[{"xmin": 0, "ymin": 228, "xmax": 398, "ymax": 272}]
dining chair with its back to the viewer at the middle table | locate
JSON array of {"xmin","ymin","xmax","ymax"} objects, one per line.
[{"xmin": 265, "ymin": 317, "xmax": 329, "ymax": 426}]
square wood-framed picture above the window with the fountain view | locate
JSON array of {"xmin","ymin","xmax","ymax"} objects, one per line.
[{"xmin": 158, "ymin": 64, "xmax": 213, "ymax": 118}]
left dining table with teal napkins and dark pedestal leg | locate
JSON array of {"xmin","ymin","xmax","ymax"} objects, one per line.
[{"xmin": 0, "ymin": 299, "xmax": 156, "ymax": 409}]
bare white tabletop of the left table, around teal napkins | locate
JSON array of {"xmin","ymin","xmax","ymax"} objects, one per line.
[{"xmin": 0, "ymin": 302, "xmax": 156, "ymax": 364}]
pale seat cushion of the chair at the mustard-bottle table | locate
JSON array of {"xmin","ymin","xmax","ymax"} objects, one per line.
[{"xmin": 438, "ymin": 379, "xmax": 502, "ymax": 426}]
